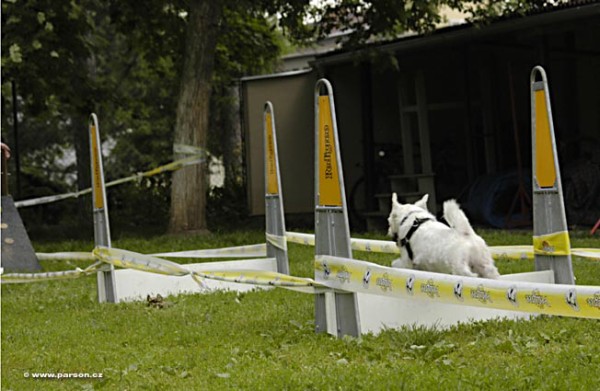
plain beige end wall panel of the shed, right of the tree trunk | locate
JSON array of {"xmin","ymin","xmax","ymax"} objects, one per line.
[{"xmin": 242, "ymin": 71, "xmax": 316, "ymax": 215}]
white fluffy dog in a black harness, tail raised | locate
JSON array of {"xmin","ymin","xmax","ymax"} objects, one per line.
[{"xmin": 388, "ymin": 193, "xmax": 500, "ymax": 278}]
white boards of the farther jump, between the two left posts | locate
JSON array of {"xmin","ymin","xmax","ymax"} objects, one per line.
[{"xmin": 115, "ymin": 258, "xmax": 277, "ymax": 301}]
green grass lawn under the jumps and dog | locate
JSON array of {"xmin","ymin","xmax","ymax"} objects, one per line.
[{"xmin": 1, "ymin": 231, "xmax": 600, "ymax": 390}]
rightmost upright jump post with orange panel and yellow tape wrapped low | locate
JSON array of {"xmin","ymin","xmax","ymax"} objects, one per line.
[{"xmin": 530, "ymin": 66, "xmax": 575, "ymax": 284}]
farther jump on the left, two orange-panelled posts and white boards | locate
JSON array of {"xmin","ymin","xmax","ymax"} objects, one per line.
[{"xmin": 90, "ymin": 102, "xmax": 289, "ymax": 303}]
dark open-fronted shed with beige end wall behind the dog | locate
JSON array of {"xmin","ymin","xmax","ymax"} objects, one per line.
[{"xmin": 244, "ymin": 11, "xmax": 600, "ymax": 224}]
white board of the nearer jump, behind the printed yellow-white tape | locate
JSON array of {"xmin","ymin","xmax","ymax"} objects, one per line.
[{"xmin": 358, "ymin": 270, "xmax": 554, "ymax": 335}]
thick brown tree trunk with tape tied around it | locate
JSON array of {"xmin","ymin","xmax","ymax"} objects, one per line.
[{"xmin": 169, "ymin": 0, "xmax": 222, "ymax": 232}]
